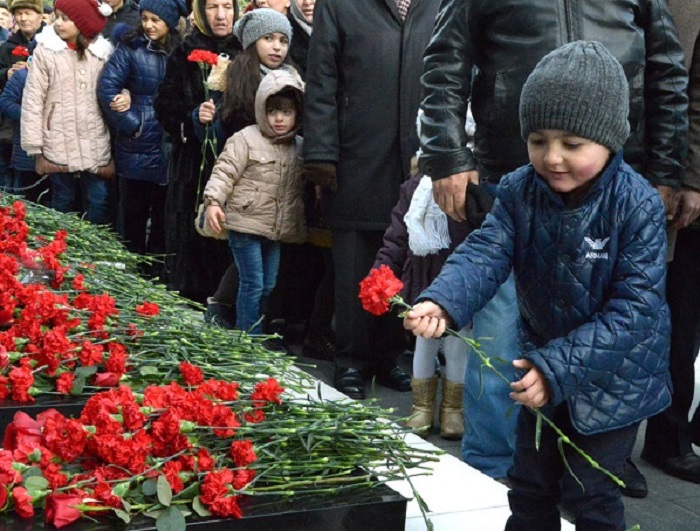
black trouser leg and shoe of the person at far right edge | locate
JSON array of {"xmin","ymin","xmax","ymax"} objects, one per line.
[{"xmin": 643, "ymin": 229, "xmax": 700, "ymax": 459}]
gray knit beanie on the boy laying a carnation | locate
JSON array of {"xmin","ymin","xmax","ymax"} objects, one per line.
[{"xmin": 520, "ymin": 41, "xmax": 630, "ymax": 153}]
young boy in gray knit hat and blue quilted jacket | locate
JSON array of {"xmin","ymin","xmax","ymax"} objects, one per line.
[{"xmin": 404, "ymin": 41, "xmax": 671, "ymax": 530}]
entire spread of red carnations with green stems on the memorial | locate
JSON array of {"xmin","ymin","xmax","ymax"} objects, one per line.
[{"xmin": 0, "ymin": 194, "xmax": 436, "ymax": 531}]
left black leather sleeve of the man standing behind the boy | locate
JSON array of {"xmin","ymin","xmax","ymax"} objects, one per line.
[{"xmin": 418, "ymin": 0, "xmax": 475, "ymax": 179}]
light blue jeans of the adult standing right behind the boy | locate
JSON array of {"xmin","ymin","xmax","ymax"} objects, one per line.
[{"xmin": 462, "ymin": 273, "xmax": 520, "ymax": 478}]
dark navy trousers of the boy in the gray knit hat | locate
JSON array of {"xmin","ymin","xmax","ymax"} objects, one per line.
[{"xmin": 506, "ymin": 403, "xmax": 639, "ymax": 531}]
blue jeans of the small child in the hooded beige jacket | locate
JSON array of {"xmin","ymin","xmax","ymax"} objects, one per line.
[{"xmin": 228, "ymin": 231, "xmax": 280, "ymax": 334}]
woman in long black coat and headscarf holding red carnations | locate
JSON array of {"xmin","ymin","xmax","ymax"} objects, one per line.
[{"xmin": 154, "ymin": 0, "xmax": 242, "ymax": 302}]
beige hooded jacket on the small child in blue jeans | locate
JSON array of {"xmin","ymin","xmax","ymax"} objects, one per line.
[{"xmin": 204, "ymin": 70, "xmax": 306, "ymax": 242}]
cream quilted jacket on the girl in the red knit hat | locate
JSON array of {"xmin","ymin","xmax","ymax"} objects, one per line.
[{"xmin": 20, "ymin": 26, "xmax": 113, "ymax": 173}]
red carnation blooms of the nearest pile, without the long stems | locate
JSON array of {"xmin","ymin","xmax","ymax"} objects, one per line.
[{"xmin": 0, "ymin": 372, "xmax": 283, "ymax": 529}]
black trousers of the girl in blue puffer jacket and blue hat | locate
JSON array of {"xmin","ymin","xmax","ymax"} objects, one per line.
[{"xmin": 120, "ymin": 177, "xmax": 167, "ymax": 254}]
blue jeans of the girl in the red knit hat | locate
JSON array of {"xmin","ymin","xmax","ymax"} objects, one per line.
[{"xmin": 51, "ymin": 171, "xmax": 109, "ymax": 225}]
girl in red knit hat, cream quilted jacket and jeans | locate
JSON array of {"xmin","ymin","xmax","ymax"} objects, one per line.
[{"xmin": 21, "ymin": 0, "xmax": 114, "ymax": 224}]
